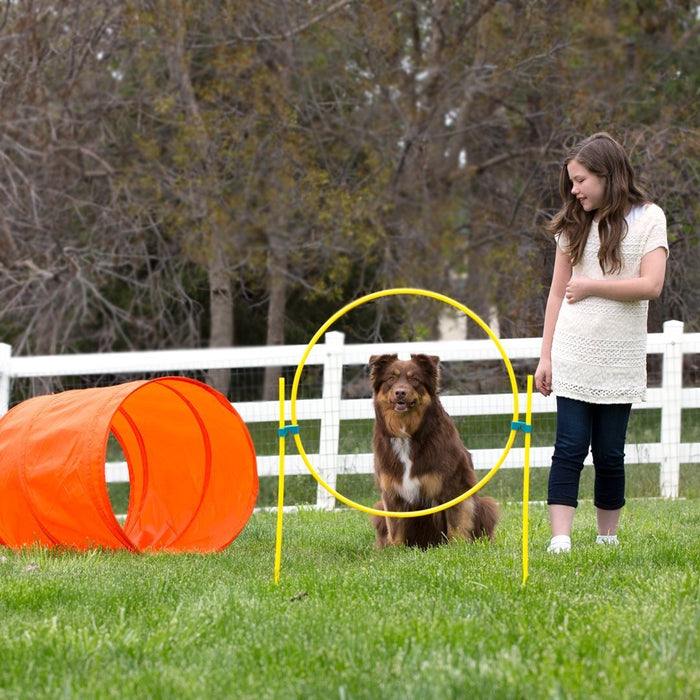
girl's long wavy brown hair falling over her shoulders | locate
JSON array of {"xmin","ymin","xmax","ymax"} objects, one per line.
[{"xmin": 547, "ymin": 131, "xmax": 649, "ymax": 274}]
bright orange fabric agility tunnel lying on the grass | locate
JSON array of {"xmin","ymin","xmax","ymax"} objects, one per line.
[{"xmin": 0, "ymin": 377, "xmax": 258, "ymax": 552}]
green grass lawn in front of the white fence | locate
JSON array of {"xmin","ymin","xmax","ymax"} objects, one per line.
[{"xmin": 0, "ymin": 499, "xmax": 700, "ymax": 700}]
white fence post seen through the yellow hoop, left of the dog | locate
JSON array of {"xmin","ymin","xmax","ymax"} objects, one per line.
[{"xmin": 316, "ymin": 331, "xmax": 345, "ymax": 510}]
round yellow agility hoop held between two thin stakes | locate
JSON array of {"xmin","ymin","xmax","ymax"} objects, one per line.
[{"xmin": 291, "ymin": 287, "xmax": 519, "ymax": 518}]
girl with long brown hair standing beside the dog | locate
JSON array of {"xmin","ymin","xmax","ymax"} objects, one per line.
[{"xmin": 535, "ymin": 133, "xmax": 668, "ymax": 553}]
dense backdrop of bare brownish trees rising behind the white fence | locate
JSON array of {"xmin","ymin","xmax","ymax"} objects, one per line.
[{"xmin": 0, "ymin": 0, "xmax": 700, "ymax": 388}]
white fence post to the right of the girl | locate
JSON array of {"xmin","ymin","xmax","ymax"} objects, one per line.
[{"xmin": 659, "ymin": 321, "xmax": 683, "ymax": 498}]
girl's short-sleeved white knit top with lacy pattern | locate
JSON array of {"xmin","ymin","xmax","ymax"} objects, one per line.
[{"xmin": 552, "ymin": 204, "xmax": 668, "ymax": 403}]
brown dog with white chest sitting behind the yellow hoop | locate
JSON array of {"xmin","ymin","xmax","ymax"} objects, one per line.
[{"xmin": 369, "ymin": 355, "xmax": 498, "ymax": 548}]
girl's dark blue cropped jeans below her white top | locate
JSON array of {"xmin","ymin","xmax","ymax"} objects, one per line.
[{"xmin": 547, "ymin": 396, "xmax": 632, "ymax": 510}]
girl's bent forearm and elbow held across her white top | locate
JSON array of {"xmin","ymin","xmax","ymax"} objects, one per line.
[{"xmin": 566, "ymin": 247, "xmax": 667, "ymax": 304}]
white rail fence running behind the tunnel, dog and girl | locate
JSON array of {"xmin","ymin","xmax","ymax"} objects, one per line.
[{"xmin": 0, "ymin": 321, "xmax": 700, "ymax": 508}]
